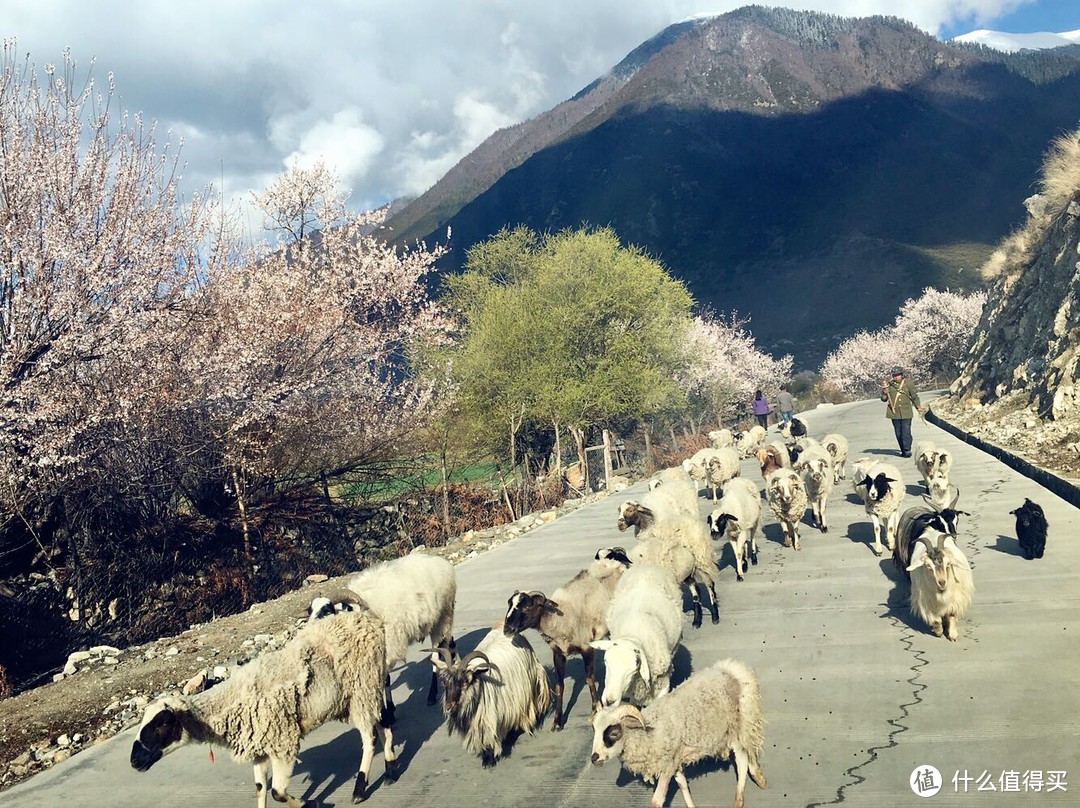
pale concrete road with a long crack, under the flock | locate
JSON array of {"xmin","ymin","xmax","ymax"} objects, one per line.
[{"xmin": 2, "ymin": 402, "xmax": 1080, "ymax": 808}]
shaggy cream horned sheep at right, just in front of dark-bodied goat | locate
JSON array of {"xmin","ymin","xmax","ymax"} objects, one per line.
[{"xmin": 907, "ymin": 528, "xmax": 975, "ymax": 643}]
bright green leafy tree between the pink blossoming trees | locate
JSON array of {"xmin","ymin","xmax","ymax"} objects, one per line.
[{"xmin": 446, "ymin": 228, "xmax": 693, "ymax": 470}]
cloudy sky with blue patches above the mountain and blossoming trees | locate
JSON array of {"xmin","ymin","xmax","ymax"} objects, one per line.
[{"xmin": 0, "ymin": 0, "xmax": 1080, "ymax": 221}]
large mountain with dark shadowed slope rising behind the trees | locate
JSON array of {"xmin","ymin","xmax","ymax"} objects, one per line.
[{"xmin": 388, "ymin": 6, "xmax": 1080, "ymax": 368}]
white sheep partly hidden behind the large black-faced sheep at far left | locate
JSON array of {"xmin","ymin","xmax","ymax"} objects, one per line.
[{"xmin": 348, "ymin": 551, "xmax": 458, "ymax": 719}]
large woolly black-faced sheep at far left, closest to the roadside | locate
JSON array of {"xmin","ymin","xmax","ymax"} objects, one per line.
[{"xmin": 131, "ymin": 607, "xmax": 397, "ymax": 808}]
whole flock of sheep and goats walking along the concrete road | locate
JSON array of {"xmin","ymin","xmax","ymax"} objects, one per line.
[{"xmin": 124, "ymin": 419, "xmax": 1045, "ymax": 808}]
